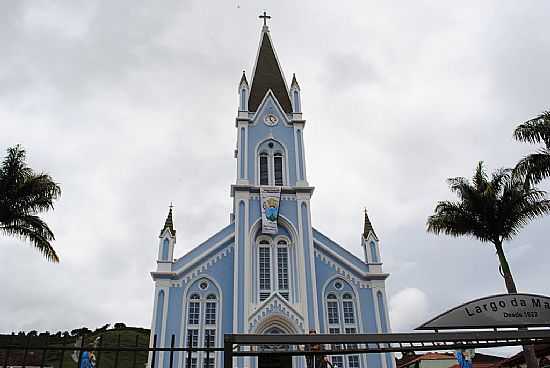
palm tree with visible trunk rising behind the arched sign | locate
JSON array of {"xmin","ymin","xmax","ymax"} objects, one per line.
[{"xmin": 427, "ymin": 162, "xmax": 550, "ymax": 368}]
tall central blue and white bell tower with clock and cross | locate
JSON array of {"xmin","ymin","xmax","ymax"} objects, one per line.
[{"xmin": 231, "ymin": 13, "xmax": 319, "ymax": 333}]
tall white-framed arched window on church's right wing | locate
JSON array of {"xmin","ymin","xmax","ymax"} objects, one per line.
[{"xmin": 325, "ymin": 278, "xmax": 360, "ymax": 368}]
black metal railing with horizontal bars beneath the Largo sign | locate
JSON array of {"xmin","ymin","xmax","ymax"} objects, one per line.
[{"xmin": 224, "ymin": 329, "xmax": 550, "ymax": 368}]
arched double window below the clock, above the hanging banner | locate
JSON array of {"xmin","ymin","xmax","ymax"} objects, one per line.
[{"xmin": 257, "ymin": 140, "xmax": 286, "ymax": 186}]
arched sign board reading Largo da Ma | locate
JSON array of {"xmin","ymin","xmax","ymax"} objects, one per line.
[{"xmin": 416, "ymin": 294, "xmax": 550, "ymax": 330}]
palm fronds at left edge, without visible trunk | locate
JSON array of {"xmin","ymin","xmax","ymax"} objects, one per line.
[{"xmin": 0, "ymin": 145, "xmax": 61, "ymax": 262}]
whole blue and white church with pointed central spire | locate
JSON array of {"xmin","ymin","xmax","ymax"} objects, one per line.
[{"xmin": 151, "ymin": 20, "xmax": 395, "ymax": 368}]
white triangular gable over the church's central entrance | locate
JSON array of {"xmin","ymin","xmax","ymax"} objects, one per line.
[{"xmin": 248, "ymin": 293, "xmax": 305, "ymax": 333}]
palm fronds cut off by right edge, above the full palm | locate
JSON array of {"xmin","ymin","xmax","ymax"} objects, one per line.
[{"xmin": 514, "ymin": 111, "xmax": 550, "ymax": 185}]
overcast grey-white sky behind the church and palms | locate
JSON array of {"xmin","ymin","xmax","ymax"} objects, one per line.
[{"xmin": 0, "ymin": 0, "xmax": 550, "ymax": 350}]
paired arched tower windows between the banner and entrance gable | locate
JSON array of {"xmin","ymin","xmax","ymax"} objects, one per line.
[{"xmin": 256, "ymin": 235, "xmax": 291, "ymax": 302}]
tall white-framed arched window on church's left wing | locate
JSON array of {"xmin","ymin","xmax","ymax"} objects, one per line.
[{"xmin": 184, "ymin": 278, "xmax": 221, "ymax": 368}]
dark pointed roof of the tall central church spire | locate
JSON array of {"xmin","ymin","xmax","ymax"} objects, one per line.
[{"xmin": 248, "ymin": 26, "xmax": 292, "ymax": 114}]
